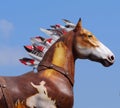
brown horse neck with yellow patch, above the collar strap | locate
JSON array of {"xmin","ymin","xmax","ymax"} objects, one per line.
[{"xmin": 38, "ymin": 32, "xmax": 75, "ymax": 80}]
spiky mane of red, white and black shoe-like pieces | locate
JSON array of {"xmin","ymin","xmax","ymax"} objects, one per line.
[{"xmin": 19, "ymin": 19, "xmax": 75, "ymax": 68}]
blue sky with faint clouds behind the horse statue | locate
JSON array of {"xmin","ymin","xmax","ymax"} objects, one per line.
[{"xmin": 0, "ymin": 0, "xmax": 120, "ymax": 108}]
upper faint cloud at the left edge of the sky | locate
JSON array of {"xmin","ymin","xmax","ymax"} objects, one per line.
[{"xmin": 0, "ymin": 19, "xmax": 14, "ymax": 37}]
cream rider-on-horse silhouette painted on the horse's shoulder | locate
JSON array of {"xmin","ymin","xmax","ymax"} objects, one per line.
[{"xmin": 26, "ymin": 81, "xmax": 56, "ymax": 108}]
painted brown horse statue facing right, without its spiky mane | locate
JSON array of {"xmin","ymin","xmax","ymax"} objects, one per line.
[{"xmin": 0, "ymin": 19, "xmax": 115, "ymax": 108}]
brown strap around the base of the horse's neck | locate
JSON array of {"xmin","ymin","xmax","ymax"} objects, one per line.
[{"xmin": 39, "ymin": 62, "xmax": 73, "ymax": 87}]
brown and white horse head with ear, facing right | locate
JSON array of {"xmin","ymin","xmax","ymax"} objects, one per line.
[{"xmin": 73, "ymin": 19, "xmax": 115, "ymax": 67}]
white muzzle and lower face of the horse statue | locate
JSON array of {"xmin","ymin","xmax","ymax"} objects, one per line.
[{"xmin": 76, "ymin": 41, "xmax": 115, "ymax": 66}]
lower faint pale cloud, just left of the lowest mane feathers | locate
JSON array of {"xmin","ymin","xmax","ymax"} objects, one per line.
[{"xmin": 0, "ymin": 46, "xmax": 25, "ymax": 66}]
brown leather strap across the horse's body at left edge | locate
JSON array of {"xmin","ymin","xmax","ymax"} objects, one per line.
[{"xmin": 0, "ymin": 77, "xmax": 14, "ymax": 108}]
